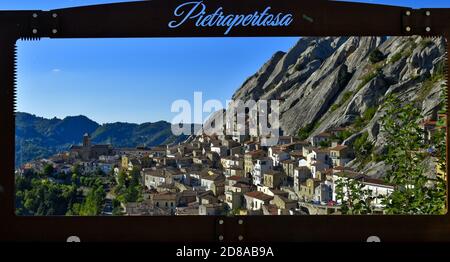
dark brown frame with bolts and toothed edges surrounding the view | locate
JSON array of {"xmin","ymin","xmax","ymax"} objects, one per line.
[{"xmin": 0, "ymin": 0, "xmax": 450, "ymax": 242}]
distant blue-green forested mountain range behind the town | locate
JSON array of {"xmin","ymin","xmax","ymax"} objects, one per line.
[{"xmin": 16, "ymin": 112, "xmax": 190, "ymax": 166}]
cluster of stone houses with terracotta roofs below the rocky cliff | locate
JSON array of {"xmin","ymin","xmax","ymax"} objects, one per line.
[{"xmin": 18, "ymin": 126, "xmax": 394, "ymax": 215}]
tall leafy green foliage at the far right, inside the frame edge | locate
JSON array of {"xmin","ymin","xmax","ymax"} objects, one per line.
[{"xmin": 382, "ymin": 97, "xmax": 446, "ymax": 214}]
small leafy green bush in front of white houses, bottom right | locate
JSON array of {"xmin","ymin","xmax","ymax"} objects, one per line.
[{"xmin": 335, "ymin": 174, "xmax": 375, "ymax": 215}]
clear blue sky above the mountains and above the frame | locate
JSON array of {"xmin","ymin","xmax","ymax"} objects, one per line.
[{"xmin": 0, "ymin": 0, "xmax": 450, "ymax": 123}]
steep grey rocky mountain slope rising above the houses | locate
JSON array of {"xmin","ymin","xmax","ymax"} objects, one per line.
[{"xmin": 233, "ymin": 36, "xmax": 446, "ymax": 174}]
